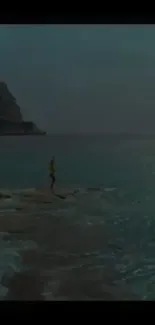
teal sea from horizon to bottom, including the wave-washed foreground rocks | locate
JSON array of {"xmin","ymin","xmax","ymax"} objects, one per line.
[{"xmin": 0, "ymin": 135, "xmax": 155, "ymax": 300}]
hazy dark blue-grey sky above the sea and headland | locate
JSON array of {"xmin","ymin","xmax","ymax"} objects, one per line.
[{"xmin": 0, "ymin": 25, "xmax": 155, "ymax": 133}]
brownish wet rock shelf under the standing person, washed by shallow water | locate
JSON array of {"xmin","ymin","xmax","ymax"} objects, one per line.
[{"xmin": 0, "ymin": 187, "xmax": 137, "ymax": 300}]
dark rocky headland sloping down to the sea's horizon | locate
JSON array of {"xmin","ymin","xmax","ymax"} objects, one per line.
[{"xmin": 0, "ymin": 82, "xmax": 45, "ymax": 135}]
